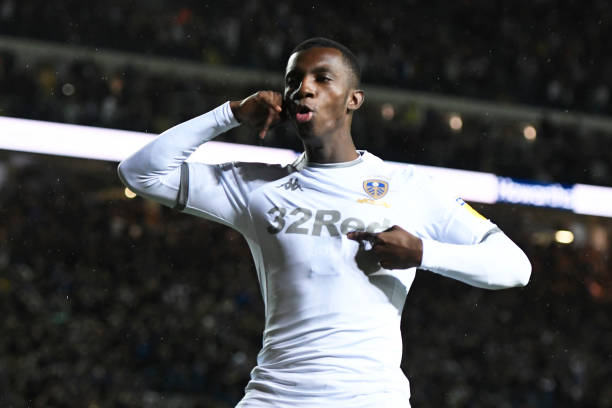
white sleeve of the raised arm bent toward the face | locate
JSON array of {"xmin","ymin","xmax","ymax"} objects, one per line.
[{"xmin": 118, "ymin": 102, "xmax": 253, "ymax": 230}]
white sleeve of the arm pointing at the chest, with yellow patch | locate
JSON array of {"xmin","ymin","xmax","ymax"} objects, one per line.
[{"xmin": 421, "ymin": 174, "xmax": 531, "ymax": 289}]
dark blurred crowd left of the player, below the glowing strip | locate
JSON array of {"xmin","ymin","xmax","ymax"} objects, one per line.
[{"xmin": 0, "ymin": 155, "xmax": 263, "ymax": 407}]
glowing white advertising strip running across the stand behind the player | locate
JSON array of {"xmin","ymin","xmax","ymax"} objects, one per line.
[{"xmin": 0, "ymin": 116, "xmax": 612, "ymax": 217}]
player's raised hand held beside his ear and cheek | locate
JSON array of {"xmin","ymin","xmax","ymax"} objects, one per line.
[{"xmin": 230, "ymin": 91, "xmax": 283, "ymax": 139}]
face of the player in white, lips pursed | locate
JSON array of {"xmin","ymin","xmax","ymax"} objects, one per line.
[{"xmin": 284, "ymin": 47, "xmax": 363, "ymax": 143}]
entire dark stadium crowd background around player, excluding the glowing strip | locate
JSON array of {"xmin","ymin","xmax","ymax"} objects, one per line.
[{"xmin": 0, "ymin": 0, "xmax": 612, "ymax": 407}]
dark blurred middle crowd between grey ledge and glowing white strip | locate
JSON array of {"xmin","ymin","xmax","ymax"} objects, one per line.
[{"xmin": 0, "ymin": 47, "xmax": 612, "ymax": 186}]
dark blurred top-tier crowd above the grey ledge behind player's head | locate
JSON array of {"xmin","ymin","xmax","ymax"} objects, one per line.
[{"xmin": 0, "ymin": 0, "xmax": 612, "ymax": 113}]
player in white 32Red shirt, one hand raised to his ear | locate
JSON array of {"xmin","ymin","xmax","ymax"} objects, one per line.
[{"xmin": 119, "ymin": 38, "xmax": 531, "ymax": 408}]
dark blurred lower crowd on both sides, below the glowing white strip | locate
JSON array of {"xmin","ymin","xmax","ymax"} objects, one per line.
[{"xmin": 0, "ymin": 153, "xmax": 612, "ymax": 408}]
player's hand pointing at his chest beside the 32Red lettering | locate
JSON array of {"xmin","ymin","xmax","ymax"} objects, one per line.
[{"xmin": 347, "ymin": 225, "xmax": 423, "ymax": 269}]
